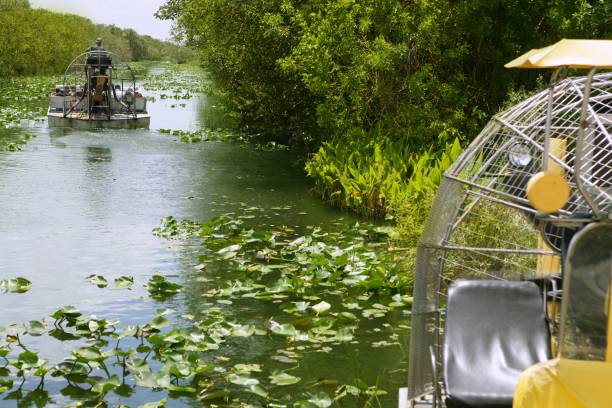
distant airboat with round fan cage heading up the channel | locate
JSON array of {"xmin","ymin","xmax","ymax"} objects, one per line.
[{"xmin": 47, "ymin": 38, "xmax": 151, "ymax": 129}]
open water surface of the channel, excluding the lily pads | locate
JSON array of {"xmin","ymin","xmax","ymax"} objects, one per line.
[{"xmin": 0, "ymin": 66, "xmax": 408, "ymax": 407}]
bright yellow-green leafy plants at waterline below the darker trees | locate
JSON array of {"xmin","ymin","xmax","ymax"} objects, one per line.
[{"xmin": 306, "ymin": 137, "xmax": 461, "ymax": 215}]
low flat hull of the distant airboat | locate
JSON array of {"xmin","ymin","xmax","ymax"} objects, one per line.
[{"xmin": 47, "ymin": 112, "xmax": 151, "ymax": 129}]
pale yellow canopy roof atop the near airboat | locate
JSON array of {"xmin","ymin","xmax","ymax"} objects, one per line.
[{"xmin": 504, "ymin": 39, "xmax": 612, "ymax": 68}]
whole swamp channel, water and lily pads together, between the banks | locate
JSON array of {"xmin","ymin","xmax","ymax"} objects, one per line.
[{"xmin": 0, "ymin": 65, "xmax": 411, "ymax": 407}]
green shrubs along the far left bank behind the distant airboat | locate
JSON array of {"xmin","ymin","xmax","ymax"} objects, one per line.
[{"xmin": 0, "ymin": 0, "xmax": 192, "ymax": 77}]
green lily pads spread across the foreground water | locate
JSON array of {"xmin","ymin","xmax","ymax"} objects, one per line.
[{"xmin": 0, "ymin": 216, "xmax": 411, "ymax": 408}]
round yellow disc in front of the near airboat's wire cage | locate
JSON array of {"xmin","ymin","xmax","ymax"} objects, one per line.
[{"xmin": 527, "ymin": 171, "xmax": 570, "ymax": 213}]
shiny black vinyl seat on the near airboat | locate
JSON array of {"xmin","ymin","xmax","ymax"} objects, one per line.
[{"xmin": 443, "ymin": 280, "xmax": 550, "ymax": 408}]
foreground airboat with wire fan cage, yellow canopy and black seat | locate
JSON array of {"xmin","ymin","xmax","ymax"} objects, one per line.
[{"xmin": 399, "ymin": 40, "xmax": 612, "ymax": 408}]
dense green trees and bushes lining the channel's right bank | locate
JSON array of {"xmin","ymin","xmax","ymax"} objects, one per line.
[{"xmin": 158, "ymin": 0, "xmax": 612, "ymax": 222}]
